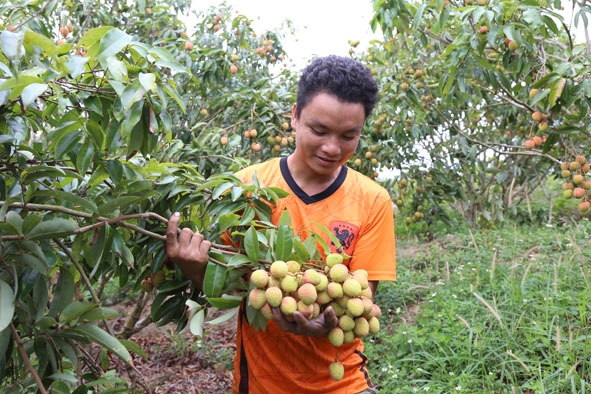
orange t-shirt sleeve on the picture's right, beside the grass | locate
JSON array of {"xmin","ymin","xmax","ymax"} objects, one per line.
[{"xmin": 349, "ymin": 192, "xmax": 396, "ymax": 281}]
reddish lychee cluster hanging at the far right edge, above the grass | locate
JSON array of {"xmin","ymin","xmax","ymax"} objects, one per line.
[{"xmin": 560, "ymin": 155, "xmax": 591, "ymax": 212}]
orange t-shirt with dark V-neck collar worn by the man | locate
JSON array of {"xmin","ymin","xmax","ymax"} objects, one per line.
[{"xmin": 232, "ymin": 158, "xmax": 396, "ymax": 394}]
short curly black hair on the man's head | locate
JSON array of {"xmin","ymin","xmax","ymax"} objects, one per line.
[{"xmin": 296, "ymin": 55, "xmax": 378, "ymax": 118}]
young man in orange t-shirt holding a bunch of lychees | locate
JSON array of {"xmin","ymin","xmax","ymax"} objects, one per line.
[{"xmin": 166, "ymin": 56, "xmax": 396, "ymax": 394}]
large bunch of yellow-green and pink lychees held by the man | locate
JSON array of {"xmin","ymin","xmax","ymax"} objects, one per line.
[{"xmin": 248, "ymin": 253, "xmax": 381, "ymax": 380}]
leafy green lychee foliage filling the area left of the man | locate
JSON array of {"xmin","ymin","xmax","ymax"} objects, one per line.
[{"xmin": 0, "ymin": 1, "xmax": 300, "ymax": 393}]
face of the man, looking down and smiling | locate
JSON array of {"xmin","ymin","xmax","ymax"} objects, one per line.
[{"xmin": 291, "ymin": 93, "xmax": 365, "ymax": 176}]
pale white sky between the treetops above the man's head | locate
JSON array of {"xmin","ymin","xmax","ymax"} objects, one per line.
[{"xmin": 193, "ymin": 0, "xmax": 379, "ymax": 66}]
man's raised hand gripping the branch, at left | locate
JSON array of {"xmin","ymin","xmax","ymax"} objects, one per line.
[{"xmin": 166, "ymin": 212, "xmax": 211, "ymax": 288}]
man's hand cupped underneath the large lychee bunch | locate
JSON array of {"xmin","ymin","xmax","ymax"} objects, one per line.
[{"xmin": 272, "ymin": 306, "xmax": 339, "ymax": 338}]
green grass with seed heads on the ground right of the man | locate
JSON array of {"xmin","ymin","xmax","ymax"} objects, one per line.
[{"xmin": 365, "ymin": 220, "xmax": 591, "ymax": 394}]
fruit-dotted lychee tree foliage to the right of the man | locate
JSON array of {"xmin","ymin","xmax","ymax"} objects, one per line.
[{"xmin": 364, "ymin": 0, "xmax": 591, "ymax": 225}]
